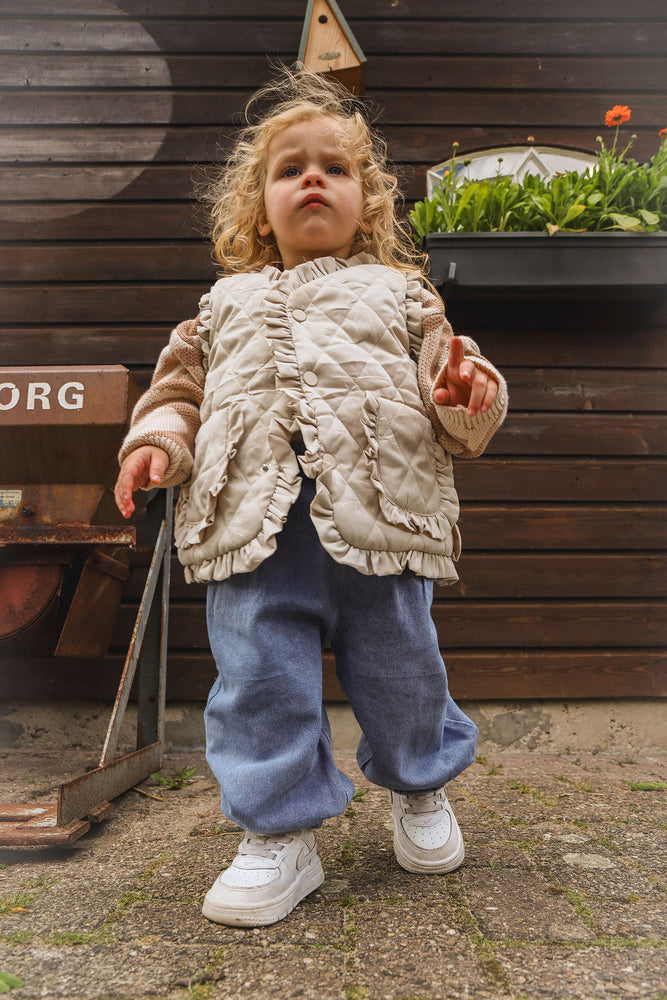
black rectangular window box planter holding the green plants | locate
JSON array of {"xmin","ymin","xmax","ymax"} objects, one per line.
[{"xmin": 424, "ymin": 232, "xmax": 667, "ymax": 299}]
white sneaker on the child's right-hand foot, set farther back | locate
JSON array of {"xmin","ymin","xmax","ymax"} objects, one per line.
[{"xmin": 389, "ymin": 786, "xmax": 465, "ymax": 874}]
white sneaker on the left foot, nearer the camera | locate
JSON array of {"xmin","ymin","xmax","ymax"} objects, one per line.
[{"xmin": 202, "ymin": 830, "xmax": 324, "ymax": 927}]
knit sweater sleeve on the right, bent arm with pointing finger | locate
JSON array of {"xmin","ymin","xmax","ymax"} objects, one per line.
[{"xmin": 418, "ymin": 288, "xmax": 508, "ymax": 458}]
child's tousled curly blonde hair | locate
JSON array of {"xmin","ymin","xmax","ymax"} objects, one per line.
[{"xmin": 203, "ymin": 67, "xmax": 427, "ymax": 274}]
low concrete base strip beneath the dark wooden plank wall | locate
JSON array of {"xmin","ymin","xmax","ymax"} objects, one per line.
[{"xmin": 0, "ymin": 699, "xmax": 667, "ymax": 754}]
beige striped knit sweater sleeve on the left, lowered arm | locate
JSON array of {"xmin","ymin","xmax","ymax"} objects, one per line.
[{"xmin": 118, "ymin": 320, "xmax": 205, "ymax": 487}]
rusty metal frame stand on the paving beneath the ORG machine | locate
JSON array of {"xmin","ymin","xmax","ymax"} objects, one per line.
[{"xmin": 0, "ymin": 490, "xmax": 173, "ymax": 846}]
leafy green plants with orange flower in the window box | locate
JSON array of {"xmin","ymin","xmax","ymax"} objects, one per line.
[{"xmin": 408, "ymin": 105, "xmax": 667, "ymax": 238}]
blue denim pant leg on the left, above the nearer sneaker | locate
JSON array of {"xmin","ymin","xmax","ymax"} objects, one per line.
[{"xmin": 205, "ymin": 480, "xmax": 354, "ymax": 834}]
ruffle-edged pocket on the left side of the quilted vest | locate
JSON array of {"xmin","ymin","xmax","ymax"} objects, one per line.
[{"xmin": 174, "ymin": 407, "xmax": 243, "ymax": 549}]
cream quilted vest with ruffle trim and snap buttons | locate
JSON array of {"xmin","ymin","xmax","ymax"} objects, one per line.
[{"xmin": 175, "ymin": 254, "xmax": 460, "ymax": 583}]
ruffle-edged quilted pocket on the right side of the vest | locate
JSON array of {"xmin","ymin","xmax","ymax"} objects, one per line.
[{"xmin": 362, "ymin": 395, "xmax": 458, "ymax": 539}]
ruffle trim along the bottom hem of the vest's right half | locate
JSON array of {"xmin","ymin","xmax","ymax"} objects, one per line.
[{"xmin": 310, "ymin": 469, "xmax": 459, "ymax": 585}]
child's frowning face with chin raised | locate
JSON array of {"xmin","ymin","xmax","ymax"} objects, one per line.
[{"xmin": 257, "ymin": 115, "xmax": 364, "ymax": 269}]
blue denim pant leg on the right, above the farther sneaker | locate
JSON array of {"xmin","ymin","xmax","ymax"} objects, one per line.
[{"xmin": 332, "ymin": 567, "xmax": 478, "ymax": 792}]
